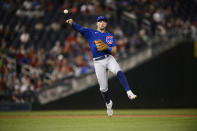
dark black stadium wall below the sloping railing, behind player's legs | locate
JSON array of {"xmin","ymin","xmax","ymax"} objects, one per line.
[{"xmin": 32, "ymin": 42, "xmax": 197, "ymax": 110}]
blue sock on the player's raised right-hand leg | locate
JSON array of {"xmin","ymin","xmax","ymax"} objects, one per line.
[{"xmin": 117, "ymin": 71, "xmax": 131, "ymax": 91}]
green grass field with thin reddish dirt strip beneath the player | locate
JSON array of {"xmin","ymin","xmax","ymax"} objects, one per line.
[{"xmin": 0, "ymin": 109, "xmax": 197, "ymax": 131}]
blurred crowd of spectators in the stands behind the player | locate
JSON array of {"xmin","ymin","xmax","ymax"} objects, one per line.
[{"xmin": 0, "ymin": 0, "xmax": 197, "ymax": 103}]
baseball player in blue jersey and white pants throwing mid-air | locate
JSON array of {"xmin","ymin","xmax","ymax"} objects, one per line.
[{"xmin": 66, "ymin": 16, "xmax": 137, "ymax": 116}]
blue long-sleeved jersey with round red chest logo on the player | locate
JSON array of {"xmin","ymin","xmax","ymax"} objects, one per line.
[{"xmin": 72, "ymin": 22, "xmax": 116, "ymax": 58}]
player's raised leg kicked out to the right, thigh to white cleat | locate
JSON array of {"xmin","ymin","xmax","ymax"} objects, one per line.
[{"xmin": 107, "ymin": 56, "xmax": 137, "ymax": 100}]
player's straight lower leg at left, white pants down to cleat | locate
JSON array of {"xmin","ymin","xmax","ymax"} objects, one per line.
[{"xmin": 94, "ymin": 60, "xmax": 113, "ymax": 116}]
